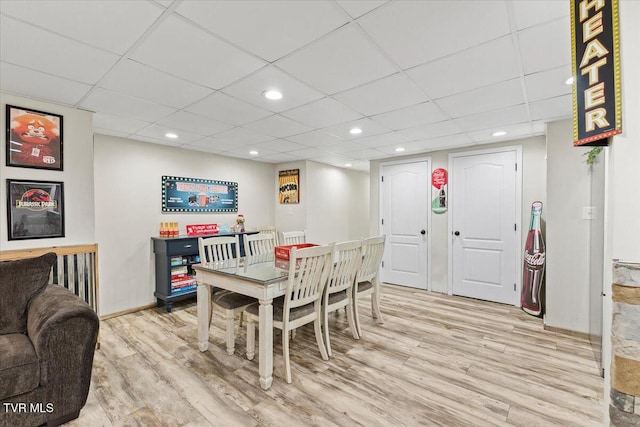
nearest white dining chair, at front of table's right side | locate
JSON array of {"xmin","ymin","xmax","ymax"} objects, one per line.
[{"xmin": 246, "ymin": 245, "xmax": 333, "ymax": 383}]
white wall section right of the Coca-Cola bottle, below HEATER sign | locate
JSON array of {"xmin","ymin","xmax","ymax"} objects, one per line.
[{"xmin": 545, "ymin": 120, "xmax": 591, "ymax": 333}]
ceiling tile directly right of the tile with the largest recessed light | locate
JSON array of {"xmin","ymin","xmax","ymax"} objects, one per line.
[{"xmin": 333, "ymin": 73, "xmax": 427, "ymax": 116}]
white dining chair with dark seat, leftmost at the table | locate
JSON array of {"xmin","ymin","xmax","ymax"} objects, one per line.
[{"xmin": 198, "ymin": 235, "xmax": 257, "ymax": 355}]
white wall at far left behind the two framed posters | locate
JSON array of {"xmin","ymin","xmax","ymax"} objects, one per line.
[{"xmin": 0, "ymin": 93, "xmax": 95, "ymax": 250}]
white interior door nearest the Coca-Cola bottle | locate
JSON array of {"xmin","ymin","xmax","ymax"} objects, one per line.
[{"xmin": 449, "ymin": 149, "xmax": 520, "ymax": 305}]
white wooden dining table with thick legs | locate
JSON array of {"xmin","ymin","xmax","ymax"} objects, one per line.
[{"xmin": 194, "ymin": 256, "xmax": 288, "ymax": 390}]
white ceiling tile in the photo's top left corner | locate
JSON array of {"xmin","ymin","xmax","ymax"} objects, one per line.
[{"xmin": 2, "ymin": 0, "xmax": 162, "ymax": 55}]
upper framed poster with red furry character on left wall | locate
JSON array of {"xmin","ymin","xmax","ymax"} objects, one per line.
[{"xmin": 6, "ymin": 105, "xmax": 63, "ymax": 171}]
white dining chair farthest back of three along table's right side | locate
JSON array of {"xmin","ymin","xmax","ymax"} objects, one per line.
[{"xmin": 353, "ymin": 236, "xmax": 385, "ymax": 337}]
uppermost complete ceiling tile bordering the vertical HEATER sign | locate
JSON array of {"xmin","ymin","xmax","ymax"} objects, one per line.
[{"xmin": 518, "ymin": 17, "xmax": 571, "ymax": 75}]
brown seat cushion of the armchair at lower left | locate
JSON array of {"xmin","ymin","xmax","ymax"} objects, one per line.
[{"xmin": 0, "ymin": 334, "xmax": 40, "ymax": 400}]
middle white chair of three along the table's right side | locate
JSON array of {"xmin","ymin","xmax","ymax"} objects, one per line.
[{"xmin": 322, "ymin": 240, "xmax": 362, "ymax": 356}]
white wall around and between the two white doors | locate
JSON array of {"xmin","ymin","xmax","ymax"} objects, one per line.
[{"xmin": 369, "ymin": 137, "xmax": 546, "ymax": 293}]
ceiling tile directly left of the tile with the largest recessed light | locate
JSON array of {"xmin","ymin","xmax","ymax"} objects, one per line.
[{"xmin": 100, "ymin": 60, "xmax": 213, "ymax": 108}]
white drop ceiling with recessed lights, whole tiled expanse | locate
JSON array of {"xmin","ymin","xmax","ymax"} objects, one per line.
[{"xmin": 0, "ymin": 0, "xmax": 572, "ymax": 170}]
